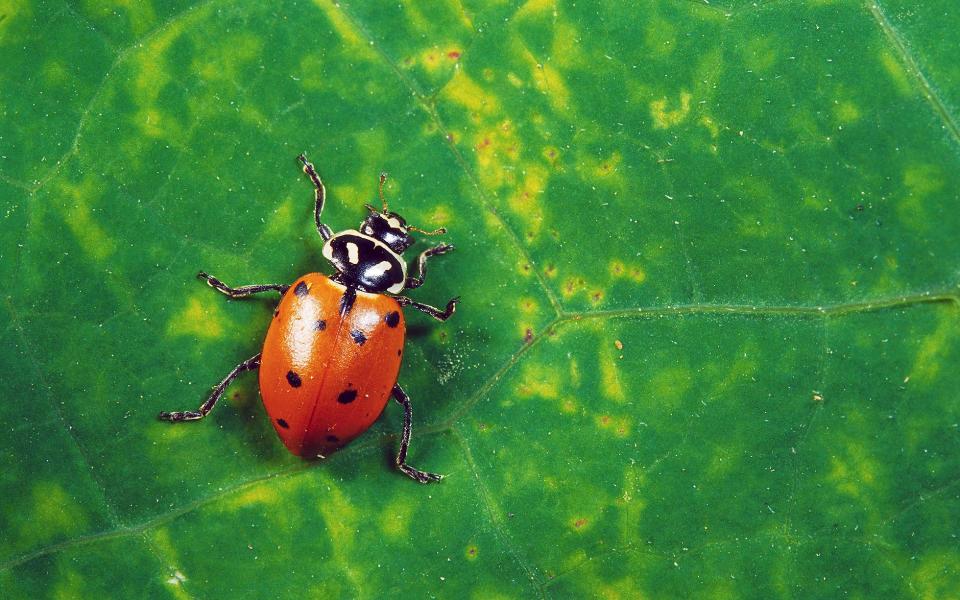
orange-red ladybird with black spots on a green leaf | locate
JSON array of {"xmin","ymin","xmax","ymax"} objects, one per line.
[{"xmin": 159, "ymin": 154, "xmax": 459, "ymax": 483}]
